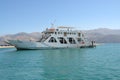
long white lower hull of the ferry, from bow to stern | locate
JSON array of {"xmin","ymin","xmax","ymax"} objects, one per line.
[{"xmin": 6, "ymin": 40, "xmax": 95, "ymax": 50}]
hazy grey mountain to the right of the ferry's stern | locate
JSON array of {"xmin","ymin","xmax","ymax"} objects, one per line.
[{"xmin": 84, "ymin": 28, "xmax": 120, "ymax": 43}]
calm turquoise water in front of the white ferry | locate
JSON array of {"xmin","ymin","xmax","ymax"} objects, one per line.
[{"xmin": 0, "ymin": 44, "xmax": 120, "ymax": 80}]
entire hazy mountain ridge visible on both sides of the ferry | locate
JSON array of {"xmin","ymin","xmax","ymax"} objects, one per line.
[{"xmin": 0, "ymin": 28, "xmax": 120, "ymax": 45}]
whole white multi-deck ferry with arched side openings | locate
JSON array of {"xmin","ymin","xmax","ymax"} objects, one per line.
[{"xmin": 6, "ymin": 26, "xmax": 95, "ymax": 50}]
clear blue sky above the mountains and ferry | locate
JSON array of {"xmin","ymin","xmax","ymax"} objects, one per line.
[{"xmin": 0, "ymin": 0, "xmax": 120, "ymax": 35}]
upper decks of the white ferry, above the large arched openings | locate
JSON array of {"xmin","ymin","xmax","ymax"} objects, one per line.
[{"xmin": 40, "ymin": 26, "xmax": 84, "ymax": 40}]
